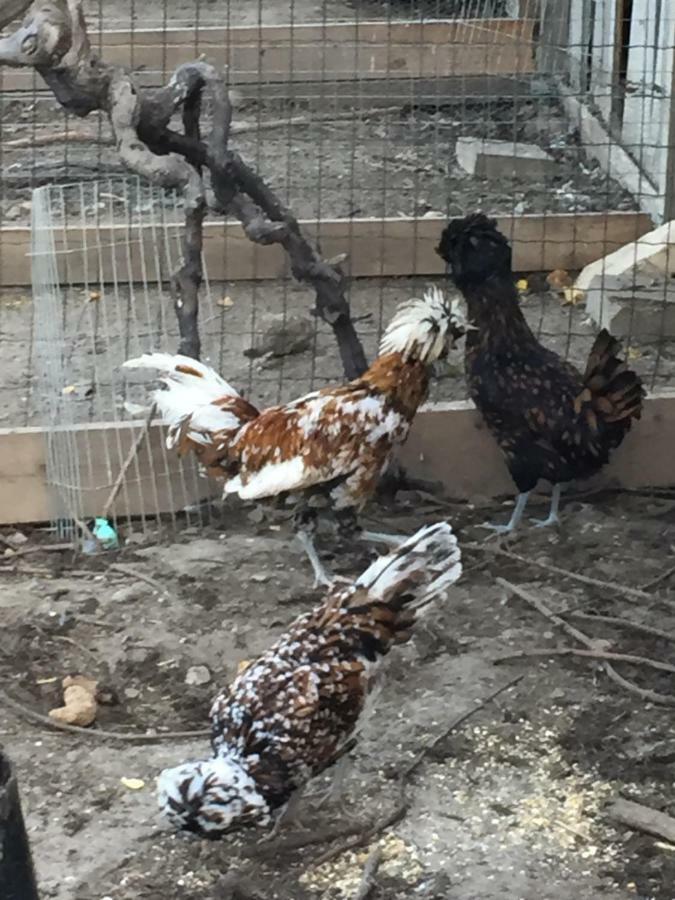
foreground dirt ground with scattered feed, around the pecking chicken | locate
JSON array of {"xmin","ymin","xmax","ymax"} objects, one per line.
[{"xmin": 0, "ymin": 493, "xmax": 675, "ymax": 900}]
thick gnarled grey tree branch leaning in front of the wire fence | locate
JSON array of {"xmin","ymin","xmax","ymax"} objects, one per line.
[{"xmin": 0, "ymin": 0, "xmax": 367, "ymax": 378}]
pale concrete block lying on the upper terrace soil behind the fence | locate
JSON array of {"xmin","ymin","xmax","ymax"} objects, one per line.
[{"xmin": 455, "ymin": 137, "xmax": 558, "ymax": 179}]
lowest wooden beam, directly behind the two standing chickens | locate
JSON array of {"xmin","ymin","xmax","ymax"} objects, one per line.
[{"xmin": 0, "ymin": 392, "xmax": 675, "ymax": 524}]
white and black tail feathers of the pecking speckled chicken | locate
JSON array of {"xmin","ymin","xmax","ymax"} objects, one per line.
[{"xmin": 355, "ymin": 522, "xmax": 462, "ymax": 608}]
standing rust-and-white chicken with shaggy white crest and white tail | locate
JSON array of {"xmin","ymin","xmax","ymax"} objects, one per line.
[{"xmin": 124, "ymin": 287, "xmax": 464, "ymax": 585}]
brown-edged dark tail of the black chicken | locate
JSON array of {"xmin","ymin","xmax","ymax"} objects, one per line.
[{"xmin": 584, "ymin": 328, "xmax": 645, "ymax": 428}]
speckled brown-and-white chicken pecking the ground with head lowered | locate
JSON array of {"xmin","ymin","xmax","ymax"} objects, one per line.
[{"xmin": 157, "ymin": 522, "xmax": 462, "ymax": 837}]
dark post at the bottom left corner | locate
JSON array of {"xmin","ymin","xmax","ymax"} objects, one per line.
[{"xmin": 0, "ymin": 750, "xmax": 38, "ymax": 900}]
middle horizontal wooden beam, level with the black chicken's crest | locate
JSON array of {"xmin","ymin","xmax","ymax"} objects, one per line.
[{"xmin": 0, "ymin": 212, "xmax": 652, "ymax": 286}]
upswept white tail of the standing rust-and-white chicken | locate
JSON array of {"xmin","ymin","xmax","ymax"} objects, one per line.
[{"xmin": 123, "ymin": 353, "xmax": 258, "ymax": 452}]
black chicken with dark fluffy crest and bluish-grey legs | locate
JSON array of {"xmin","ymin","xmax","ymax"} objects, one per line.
[{"xmin": 437, "ymin": 213, "xmax": 645, "ymax": 533}]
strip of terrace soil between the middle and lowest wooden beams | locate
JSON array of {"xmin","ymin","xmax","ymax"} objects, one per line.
[{"xmin": 0, "ymin": 274, "xmax": 675, "ymax": 427}]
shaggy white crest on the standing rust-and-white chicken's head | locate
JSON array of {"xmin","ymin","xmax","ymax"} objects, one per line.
[{"xmin": 380, "ymin": 285, "xmax": 450, "ymax": 363}]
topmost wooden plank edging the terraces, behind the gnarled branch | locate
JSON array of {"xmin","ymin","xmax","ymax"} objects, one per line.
[{"xmin": 0, "ymin": 19, "xmax": 534, "ymax": 91}]
